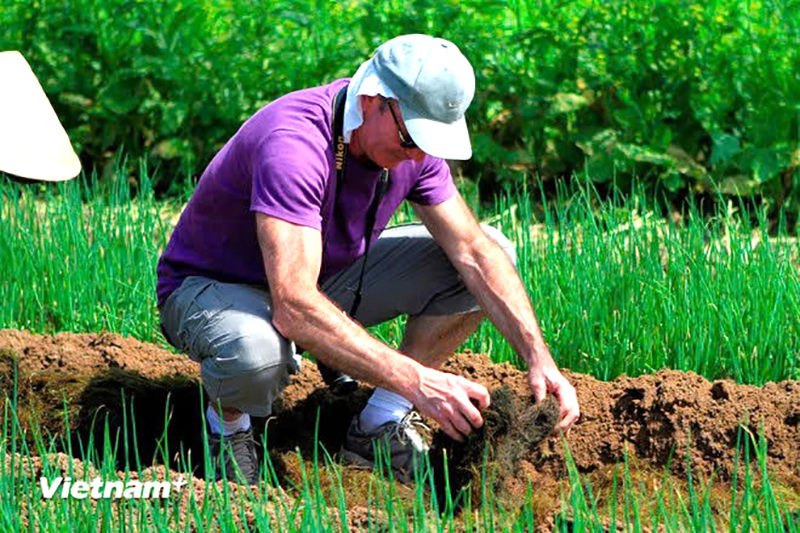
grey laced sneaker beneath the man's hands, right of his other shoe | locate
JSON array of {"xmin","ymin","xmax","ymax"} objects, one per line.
[{"xmin": 341, "ymin": 411, "xmax": 430, "ymax": 485}]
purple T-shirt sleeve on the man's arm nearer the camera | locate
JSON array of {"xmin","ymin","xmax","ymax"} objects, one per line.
[{"xmin": 250, "ymin": 129, "xmax": 330, "ymax": 230}]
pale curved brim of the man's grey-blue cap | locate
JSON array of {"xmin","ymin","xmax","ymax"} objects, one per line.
[{"xmin": 400, "ymin": 102, "xmax": 472, "ymax": 160}]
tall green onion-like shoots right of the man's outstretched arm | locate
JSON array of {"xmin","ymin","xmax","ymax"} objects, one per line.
[{"xmin": 454, "ymin": 183, "xmax": 800, "ymax": 384}]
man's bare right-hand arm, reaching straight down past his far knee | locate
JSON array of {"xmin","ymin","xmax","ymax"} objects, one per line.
[{"xmin": 414, "ymin": 194, "xmax": 580, "ymax": 430}]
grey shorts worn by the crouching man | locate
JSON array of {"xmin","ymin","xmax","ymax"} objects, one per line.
[{"xmin": 161, "ymin": 224, "xmax": 516, "ymax": 416}]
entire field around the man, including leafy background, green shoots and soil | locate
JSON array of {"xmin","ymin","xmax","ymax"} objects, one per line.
[{"xmin": 0, "ymin": 0, "xmax": 800, "ymax": 533}]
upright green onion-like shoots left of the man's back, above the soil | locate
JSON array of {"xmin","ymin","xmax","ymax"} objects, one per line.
[{"xmin": 0, "ymin": 170, "xmax": 169, "ymax": 340}]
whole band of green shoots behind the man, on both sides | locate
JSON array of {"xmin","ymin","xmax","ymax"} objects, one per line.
[{"xmin": 0, "ymin": 172, "xmax": 800, "ymax": 384}]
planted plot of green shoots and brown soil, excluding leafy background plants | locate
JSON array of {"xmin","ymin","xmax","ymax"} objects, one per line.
[{"xmin": 0, "ymin": 174, "xmax": 800, "ymax": 531}]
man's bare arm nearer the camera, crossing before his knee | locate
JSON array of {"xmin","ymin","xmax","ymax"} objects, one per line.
[{"xmin": 256, "ymin": 213, "xmax": 489, "ymax": 439}]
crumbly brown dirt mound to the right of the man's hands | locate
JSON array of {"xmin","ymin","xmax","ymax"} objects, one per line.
[{"xmin": 447, "ymin": 354, "xmax": 800, "ymax": 484}]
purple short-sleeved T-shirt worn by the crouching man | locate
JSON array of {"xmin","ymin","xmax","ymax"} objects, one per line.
[{"xmin": 156, "ymin": 79, "xmax": 456, "ymax": 307}]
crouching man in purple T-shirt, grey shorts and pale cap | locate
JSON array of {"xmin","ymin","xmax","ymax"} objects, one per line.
[{"xmin": 158, "ymin": 35, "xmax": 579, "ymax": 482}]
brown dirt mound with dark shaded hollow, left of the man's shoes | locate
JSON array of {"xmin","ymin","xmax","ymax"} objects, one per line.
[{"xmin": 0, "ymin": 330, "xmax": 203, "ymax": 468}]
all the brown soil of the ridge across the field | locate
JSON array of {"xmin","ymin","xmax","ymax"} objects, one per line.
[{"xmin": 0, "ymin": 330, "xmax": 800, "ymax": 525}]
